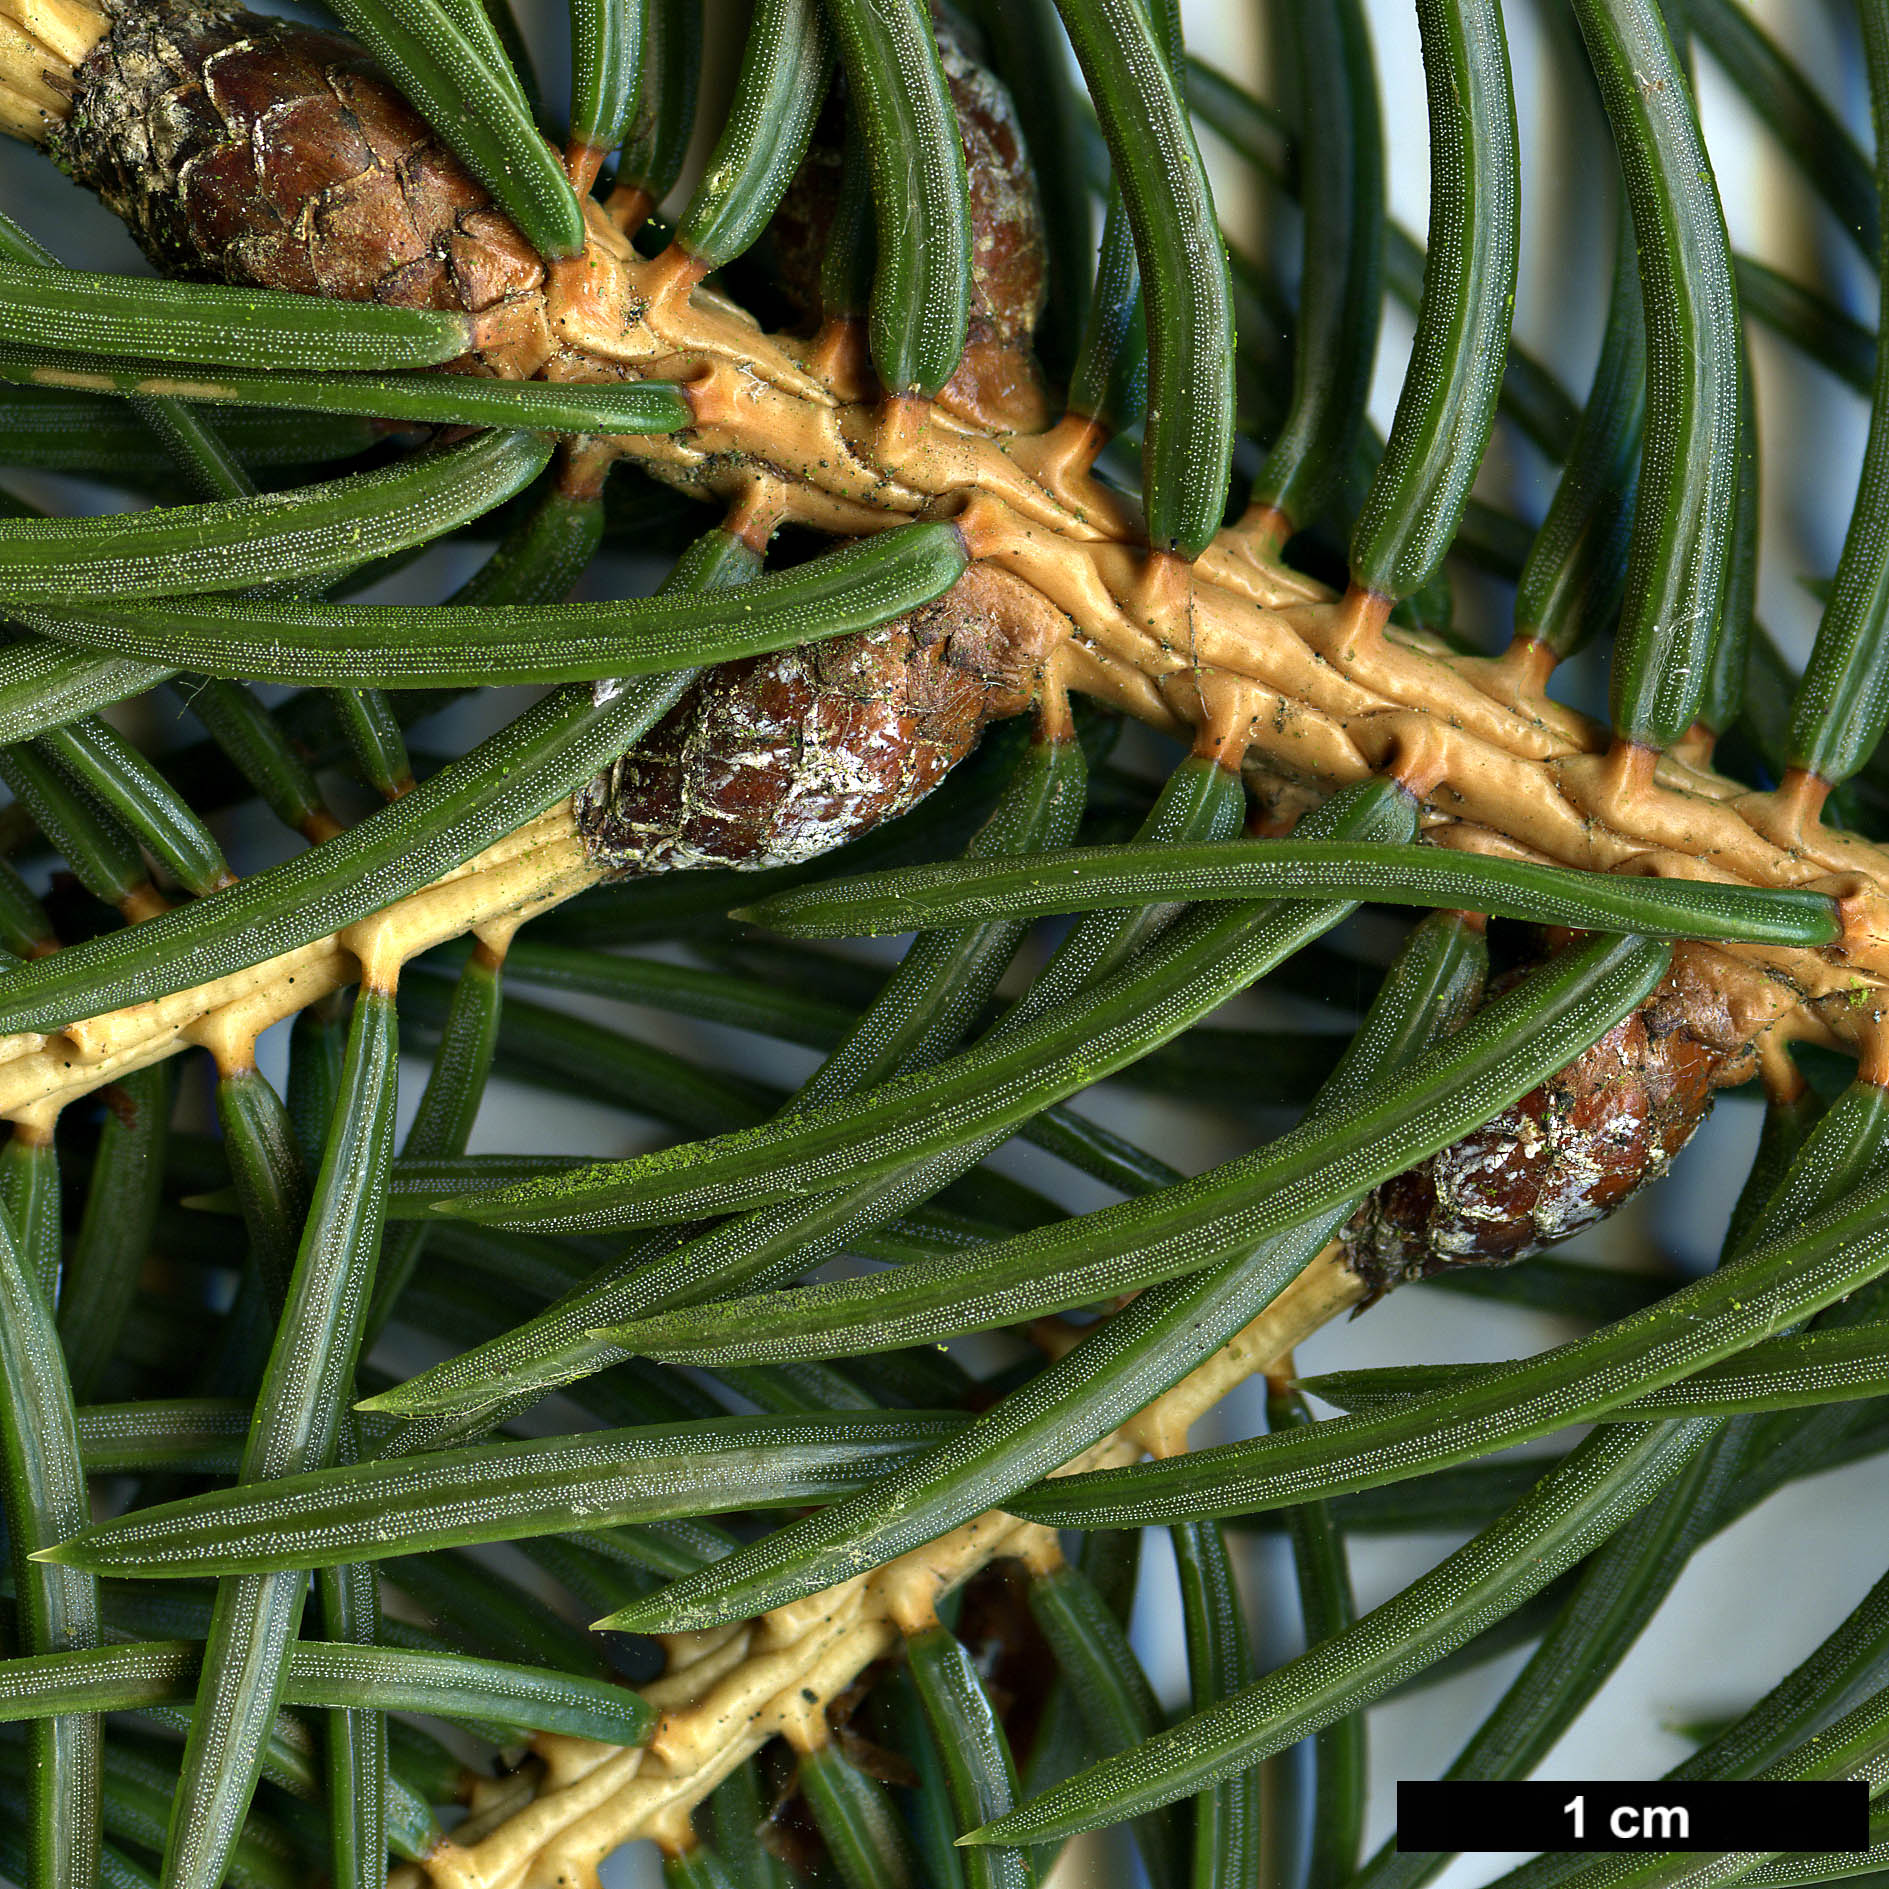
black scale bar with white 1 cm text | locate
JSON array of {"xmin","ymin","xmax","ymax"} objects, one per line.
[{"xmin": 1398, "ymin": 1779, "xmax": 1870, "ymax": 1851}]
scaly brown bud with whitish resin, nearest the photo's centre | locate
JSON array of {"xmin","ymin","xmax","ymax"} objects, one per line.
[{"xmin": 574, "ymin": 565, "xmax": 1054, "ymax": 873}]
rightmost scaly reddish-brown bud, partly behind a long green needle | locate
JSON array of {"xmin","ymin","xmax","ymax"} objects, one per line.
[{"xmin": 1343, "ymin": 946, "xmax": 1755, "ymax": 1292}]
